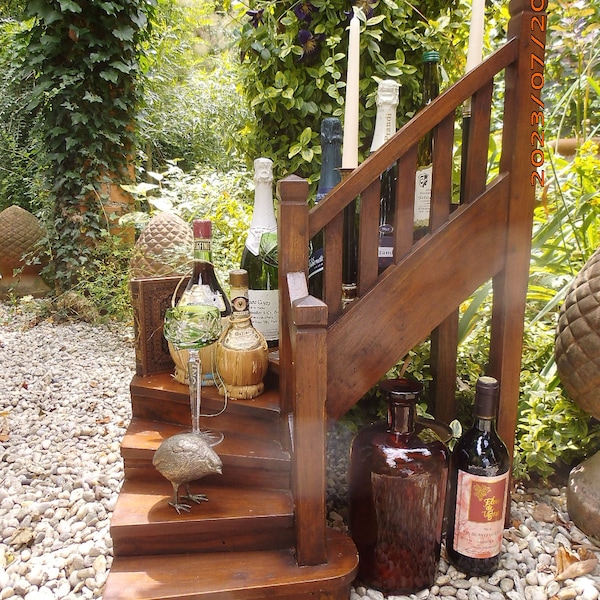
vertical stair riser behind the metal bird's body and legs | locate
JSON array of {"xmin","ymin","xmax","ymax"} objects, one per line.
[{"xmin": 124, "ymin": 458, "xmax": 290, "ymax": 490}]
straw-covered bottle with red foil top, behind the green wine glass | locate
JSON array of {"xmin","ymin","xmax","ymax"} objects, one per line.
[{"xmin": 170, "ymin": 219, "xmax": 231, "ymax": 386}]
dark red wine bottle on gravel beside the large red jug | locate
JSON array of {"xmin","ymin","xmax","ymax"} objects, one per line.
[{"xmin": 446, "ymin": 377, "xmax": 510, "ymax": 575}]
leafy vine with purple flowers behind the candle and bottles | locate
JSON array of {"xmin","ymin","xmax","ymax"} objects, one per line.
[{"xmin": 232, "ymin": 0, "xmax": 480, "ymax": 182}]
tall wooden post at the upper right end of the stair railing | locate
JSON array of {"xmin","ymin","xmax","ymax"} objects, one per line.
[{"xmin": 490, "ymin": 0, "xmax": 547, "ymax": 457}]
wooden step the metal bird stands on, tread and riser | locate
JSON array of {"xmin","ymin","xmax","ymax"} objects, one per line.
[{"xmin": 110, "ymin": 475, "xmax": 294, "ymax": 556}]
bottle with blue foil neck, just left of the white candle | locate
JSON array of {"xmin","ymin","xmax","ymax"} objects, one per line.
[{"xmin": 308, "ymin": 117, "xmax": 342, "ymax": 298}]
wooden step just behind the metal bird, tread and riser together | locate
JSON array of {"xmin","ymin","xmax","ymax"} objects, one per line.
[{"xmin": 121, "ymin": 417, "xmax": 291, "ymax": 489}]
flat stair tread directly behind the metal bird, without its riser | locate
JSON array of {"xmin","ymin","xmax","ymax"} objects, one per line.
[{"xmin": 121, "ymin": 417, "xmax": 290, "ymax": 470}]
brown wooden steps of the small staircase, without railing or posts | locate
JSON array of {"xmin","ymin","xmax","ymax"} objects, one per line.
[{"xmin": 103, "ymin": 373, "xmax": 357, "ymax": 600}]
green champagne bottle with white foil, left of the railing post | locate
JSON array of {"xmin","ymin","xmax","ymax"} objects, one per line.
[{"xmin": 240, "ymin": 158, "xmax": 279, "ymax": 347}]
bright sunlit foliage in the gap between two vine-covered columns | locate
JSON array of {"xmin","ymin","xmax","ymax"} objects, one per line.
[{"xmin": 140, "ymin": 0, "xmax": 249, "ymax": 171}]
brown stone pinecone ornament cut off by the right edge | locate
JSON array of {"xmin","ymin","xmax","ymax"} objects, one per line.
[{"xmin": 554, "ymin": 248, "xmax": 600, "ymax": 419}]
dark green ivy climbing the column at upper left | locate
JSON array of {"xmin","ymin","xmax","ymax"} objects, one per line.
[{"xmin": 22, "ymin": 0, "xmax": 156, "ymax": 290}]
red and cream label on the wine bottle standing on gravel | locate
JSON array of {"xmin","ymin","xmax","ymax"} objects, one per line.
[{"xmin": 453, "ymin": 470, "xmax": 509, "ymax": 558}]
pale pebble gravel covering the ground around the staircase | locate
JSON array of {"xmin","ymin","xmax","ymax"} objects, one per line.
[{"xmin": 0, "ymin": 303, "xmax": 600, "ymax": 600}]
